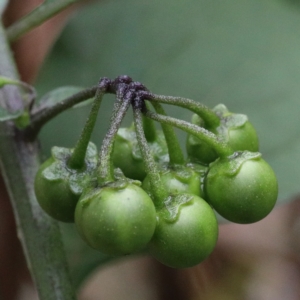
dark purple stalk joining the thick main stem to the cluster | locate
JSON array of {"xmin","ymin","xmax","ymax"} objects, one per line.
[{"xmin": 25, "ymin": 86, "xmax": 98, "ymax": 140}]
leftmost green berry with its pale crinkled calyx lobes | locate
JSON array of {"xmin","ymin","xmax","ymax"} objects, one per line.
[{"xmin": 34, "ymin": 143, "xmax": 98, "ymax": 222}]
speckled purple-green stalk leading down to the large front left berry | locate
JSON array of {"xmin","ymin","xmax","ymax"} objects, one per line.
[{"xmin": 97, "ymin": 93, "xmax": 131, "ymax": 185}]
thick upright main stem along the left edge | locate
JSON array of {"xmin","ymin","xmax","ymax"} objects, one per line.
[{"xmin": 0, "ymin": 25, "xmax": 75, "ymax": 300}]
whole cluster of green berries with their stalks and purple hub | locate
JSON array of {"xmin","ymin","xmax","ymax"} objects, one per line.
[{"xmin": 35, "ymin": 76, "xmax": 278, "ymax": 268}]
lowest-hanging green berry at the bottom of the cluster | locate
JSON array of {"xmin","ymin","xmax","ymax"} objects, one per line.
[{"xmin": 149, "ymin": 194, "xmax": 218, "ymax": 268}]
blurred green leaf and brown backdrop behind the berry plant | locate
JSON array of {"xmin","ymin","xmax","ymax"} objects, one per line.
[{"xmin": 0, "ymin": 0, "xmax": 300, "ymax": 300}]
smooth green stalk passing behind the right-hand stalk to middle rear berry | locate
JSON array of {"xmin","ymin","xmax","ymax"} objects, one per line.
[{"xmin": 152, "ymin": 102, "xmax": 184, "ymax": 165}]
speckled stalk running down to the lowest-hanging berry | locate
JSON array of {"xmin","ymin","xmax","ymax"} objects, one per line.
[{"xmin": 133, "ymin": 106, "xmax": 168, "ymax": 207}]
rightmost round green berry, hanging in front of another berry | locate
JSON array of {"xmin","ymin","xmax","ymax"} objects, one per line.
[{"xmin": 204, "ymin": 151, "xmax": 278, "ymax": 224}]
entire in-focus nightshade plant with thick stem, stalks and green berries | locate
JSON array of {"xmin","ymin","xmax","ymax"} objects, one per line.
[{"xmin": 0, "ymin": 0, "xmax": 278, "ymax": 300}]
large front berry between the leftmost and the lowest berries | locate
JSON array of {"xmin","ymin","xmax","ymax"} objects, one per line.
[{"xmin": 75, "ymin": 183, "xmax": 156, "ymax": 255}]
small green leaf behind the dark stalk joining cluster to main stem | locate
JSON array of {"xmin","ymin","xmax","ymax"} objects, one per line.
[{"xmin": 35, "ymin": 86, "xmax": 93, "ymax": 111}]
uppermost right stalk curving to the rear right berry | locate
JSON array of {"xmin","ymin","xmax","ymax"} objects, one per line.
[{"xmin": 147, "ymin": 94, "xmax": 220, "ymax": 128}]
